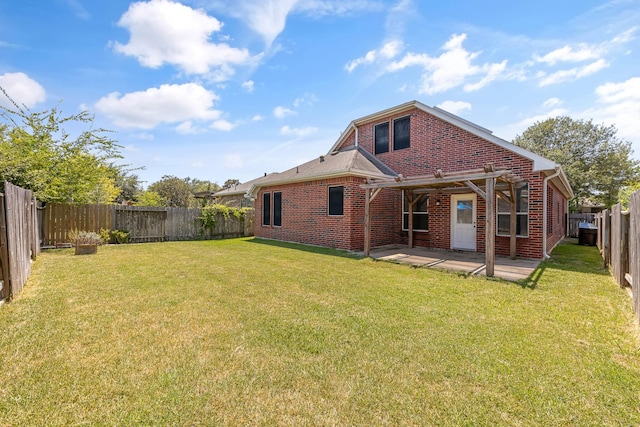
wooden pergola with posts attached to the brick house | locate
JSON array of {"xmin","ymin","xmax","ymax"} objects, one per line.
[{"xmin": 361, "ymin": 163, "xmax": 523, "ymax": 277}]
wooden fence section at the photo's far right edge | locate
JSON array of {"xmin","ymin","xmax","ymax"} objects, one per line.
[{"xmin": 596, "ymin": 191, "xmax": 640, "ymax": 322}]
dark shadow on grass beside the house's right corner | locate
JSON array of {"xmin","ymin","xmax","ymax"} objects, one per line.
[{"xmin": 516, "ymin": 239, "xmax": 610, "ymax": 289}]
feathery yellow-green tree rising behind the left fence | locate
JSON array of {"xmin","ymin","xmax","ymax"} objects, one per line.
[{"xmin": 0, "ymin": 87, "xmax": 121, "ymax": 203}]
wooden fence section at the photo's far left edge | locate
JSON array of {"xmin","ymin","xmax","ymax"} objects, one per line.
[{"xmin": 0, "ymin": 181, "xmax": 40, "ymax": 300}]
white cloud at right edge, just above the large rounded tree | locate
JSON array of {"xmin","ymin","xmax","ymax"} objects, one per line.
[{"xmin": 583, "ymin": 77, "xmax": 640, "ymax": 149}]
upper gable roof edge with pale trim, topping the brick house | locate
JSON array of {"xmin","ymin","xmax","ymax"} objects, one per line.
[{"xmin": 329, "ymin": 101, "xmax": 573, "ymax": 198}]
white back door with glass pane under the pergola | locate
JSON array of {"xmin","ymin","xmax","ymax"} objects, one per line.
[{"xmin": 451, "ymin": 193, "xmax": 476, "ymax": 251}]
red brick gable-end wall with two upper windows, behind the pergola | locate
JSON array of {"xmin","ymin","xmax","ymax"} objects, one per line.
[{"xmin": 343, "ymin": 109, "xmax": 556, "ymax": 258}]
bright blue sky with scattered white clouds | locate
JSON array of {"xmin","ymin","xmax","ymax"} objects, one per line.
[{"xmin": 0, "ymin": 0, "xmax": 640, "ymax": 185}]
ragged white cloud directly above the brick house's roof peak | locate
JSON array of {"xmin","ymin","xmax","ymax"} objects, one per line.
[{"xmin": 386, "ymin": 34, "xmax": 511, "ymax": 95}]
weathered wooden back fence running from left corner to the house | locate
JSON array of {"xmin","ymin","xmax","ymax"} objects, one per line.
[{"xmin": 40, "ymin": 203, "xmax": 253, "ymax": 246}]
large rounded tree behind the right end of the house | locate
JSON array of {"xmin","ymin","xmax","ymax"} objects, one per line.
[{"xmin": 513, "ymin": 116, "xmax": 640, "ymax": 211}]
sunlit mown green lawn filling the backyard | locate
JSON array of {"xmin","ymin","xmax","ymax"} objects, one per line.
[{"xmin": 0, "ymin": 239, "xmax": 640, "ymax": 426}]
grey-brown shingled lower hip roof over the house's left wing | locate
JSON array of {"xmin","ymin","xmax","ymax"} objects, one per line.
[{"xmin": 246, "ymin": 146, "xmax": 397, "ymax": 197}]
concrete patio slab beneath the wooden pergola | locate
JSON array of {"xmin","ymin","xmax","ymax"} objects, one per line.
[{"xmin": 370, "ymin": 245, "xmax": 540, "ymax": 281}]
